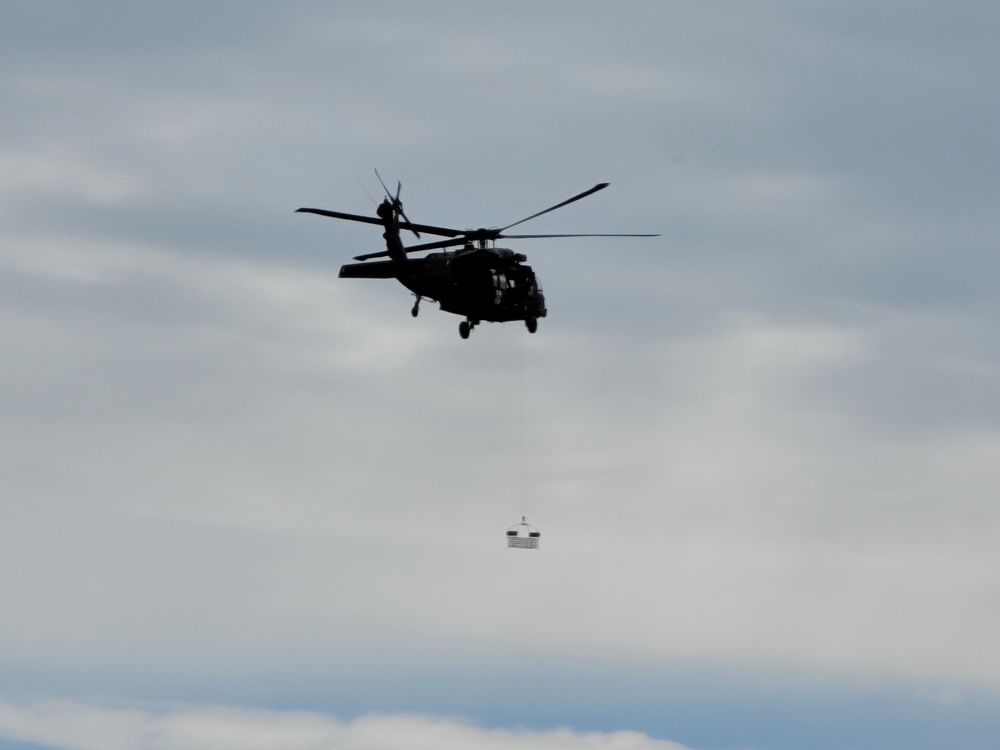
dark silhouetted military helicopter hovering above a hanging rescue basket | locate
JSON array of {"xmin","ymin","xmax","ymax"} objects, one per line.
[{"xmin": 297, "ymin": 175, "xmax": 659, "ymax": 339}]
